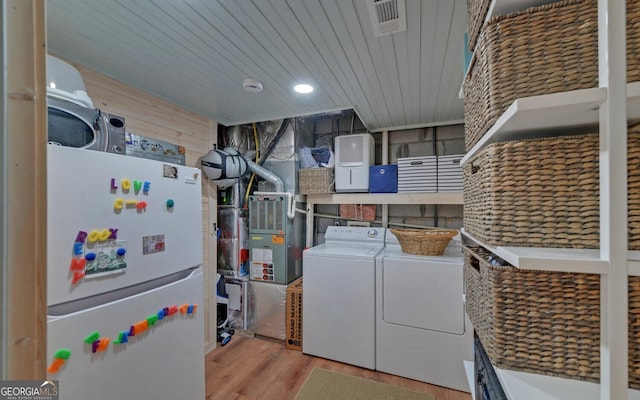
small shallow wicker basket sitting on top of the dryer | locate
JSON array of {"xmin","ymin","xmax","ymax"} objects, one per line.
[{"xmin": 390, "ymin": 228, "xmax": 458, "ymax": 256}]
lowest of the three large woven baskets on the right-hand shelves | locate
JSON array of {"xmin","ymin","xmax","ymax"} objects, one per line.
[{"xmin": 463, "ymin": 247, "xmax": 640, "ymax": 389}]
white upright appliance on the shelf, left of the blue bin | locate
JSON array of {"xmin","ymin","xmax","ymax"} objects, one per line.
[{"xmin": 335, "ymin": 133, "xmax": 375, "ymax": 193}]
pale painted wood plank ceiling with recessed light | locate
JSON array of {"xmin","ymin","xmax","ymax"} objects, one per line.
[{"xmin": 47, "ymin": 0, "xmax": 466, "ymax": 132}]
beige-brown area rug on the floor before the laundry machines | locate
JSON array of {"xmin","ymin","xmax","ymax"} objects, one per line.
[{"xmin": 295, "ymin": 368, "xmax": 435, "ymax": 400}]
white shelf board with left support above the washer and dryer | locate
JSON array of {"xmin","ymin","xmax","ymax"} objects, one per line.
[{"xmin": 307, "ymin": 192, "xmax": 463, "ymax": 247}]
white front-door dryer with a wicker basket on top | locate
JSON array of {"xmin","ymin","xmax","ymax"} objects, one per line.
[{"xmin": 376, "ymin": 231, "xmax": 473, "ymax": 392}]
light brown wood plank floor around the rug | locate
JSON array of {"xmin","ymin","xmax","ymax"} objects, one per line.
[{"xmin": 205, "ymin": 333, "xmax": 471, "ymax": 400}]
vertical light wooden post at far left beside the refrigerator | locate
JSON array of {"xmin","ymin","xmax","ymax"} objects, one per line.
[{"xmin": 2, "ymin": 0, "xmax": 47, "ymax": 379}]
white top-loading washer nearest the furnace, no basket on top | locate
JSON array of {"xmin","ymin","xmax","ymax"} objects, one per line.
[{"xmin": 302, "ymin": 226, "xmax": 385, "ymax": 369}]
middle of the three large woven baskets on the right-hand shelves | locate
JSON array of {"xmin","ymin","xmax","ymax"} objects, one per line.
[{"xmin": 463, "ymin": 124, "xmax": 640, "ymax": 250}]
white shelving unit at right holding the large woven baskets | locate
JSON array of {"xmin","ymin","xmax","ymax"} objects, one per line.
[{"xmin": 462, "ymin": 0, "xmax": 640, "ymax": 400}]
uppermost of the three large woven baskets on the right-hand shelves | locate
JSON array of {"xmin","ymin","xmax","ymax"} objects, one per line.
[{"xmin": 464, "ymin": 0, "xmax": 640, "ymax": 150}]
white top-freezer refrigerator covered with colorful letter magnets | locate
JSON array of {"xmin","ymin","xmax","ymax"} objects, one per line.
[{"xmin": 47, "ymin": 145, "xmax": 205, "ymax": 400}]
